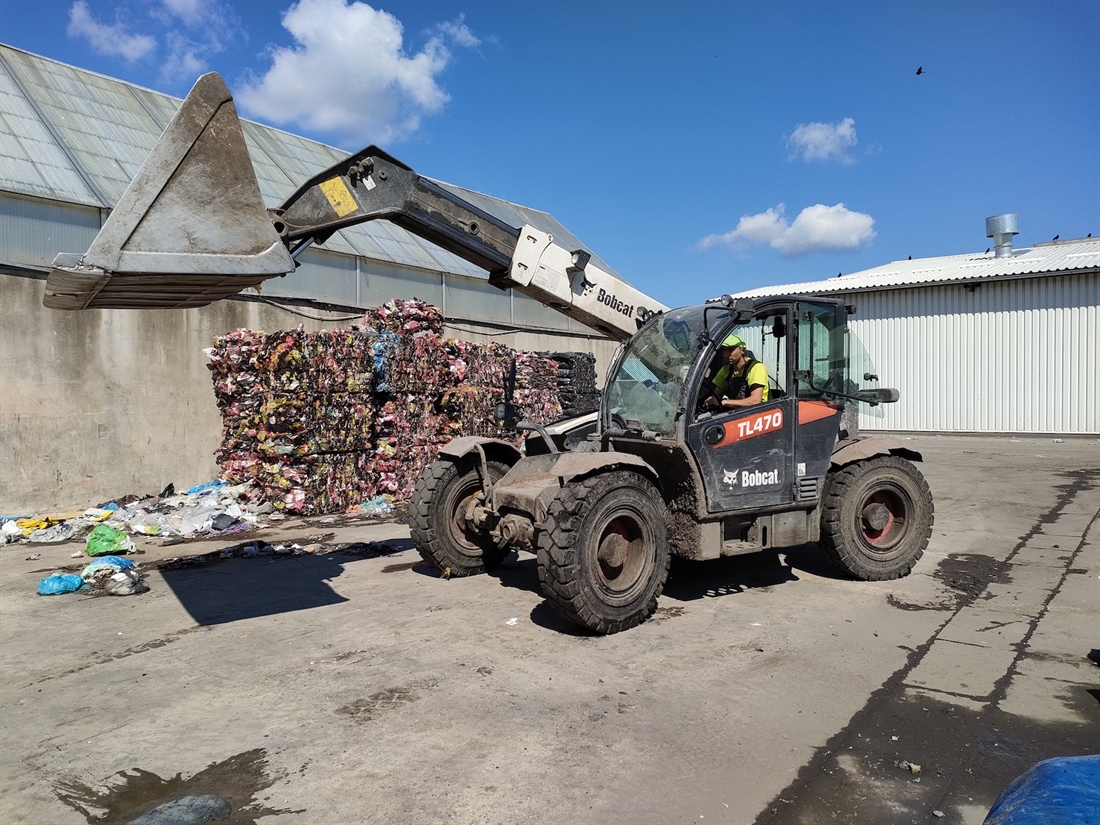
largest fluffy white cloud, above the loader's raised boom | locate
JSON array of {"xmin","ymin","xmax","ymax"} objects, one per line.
[{"xmin": 235, "ymin": 0, "xmax": 479, "ymax": 149}]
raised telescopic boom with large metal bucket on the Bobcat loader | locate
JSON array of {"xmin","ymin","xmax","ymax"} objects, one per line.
[{"xmin": 44, "ymin": 74, "xmax": 667, "ymax": 341}]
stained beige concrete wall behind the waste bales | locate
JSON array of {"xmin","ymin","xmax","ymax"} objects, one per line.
[{"xmin": 0, "ymin": 274, "xmax": 615, "ymax": 515}]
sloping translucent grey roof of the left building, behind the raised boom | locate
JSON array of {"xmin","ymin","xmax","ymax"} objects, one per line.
[{"xmin": 0, "ymin": 44, "xmax": 619, "ymax": 288}]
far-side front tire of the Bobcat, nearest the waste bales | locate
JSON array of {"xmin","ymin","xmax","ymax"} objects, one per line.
[{"xmin": 408, "ymin": 455, "xmax": 508, "ymax": 578}]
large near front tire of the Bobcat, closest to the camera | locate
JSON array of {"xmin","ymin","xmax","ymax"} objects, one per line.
[{"xmin": 538, "ymin": 472, "xmax": 670, "ymax": 634}]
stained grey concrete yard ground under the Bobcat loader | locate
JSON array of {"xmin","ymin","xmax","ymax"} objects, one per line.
[{"xmin": 0, "ymin": 436, "xmax": 1100, "ymax": 825}]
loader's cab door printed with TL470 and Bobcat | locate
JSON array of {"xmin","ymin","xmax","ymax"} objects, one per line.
[{"xmin": 685, "ymin": 310, "xmax": 798, "ymax": 513}]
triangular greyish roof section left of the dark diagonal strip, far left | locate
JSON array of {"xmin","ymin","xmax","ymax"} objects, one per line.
[{"xmin": 0, "ymin": 55, "xmax": 100, "ymax": 207}]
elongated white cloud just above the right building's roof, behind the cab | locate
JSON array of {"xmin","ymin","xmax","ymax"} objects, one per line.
[{"xmin": 697, "ymin": 204, "xmax": 875, "ymax": 257}]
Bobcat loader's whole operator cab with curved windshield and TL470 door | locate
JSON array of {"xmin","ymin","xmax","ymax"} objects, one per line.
[{"xmin": 601, "ymin": 297, "xmax": 891, "ymax": 515}]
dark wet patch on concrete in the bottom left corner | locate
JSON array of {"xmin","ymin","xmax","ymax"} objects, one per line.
[{"xmin": 54, "ymin": 748, "xmax": 305, "ymax": 825}]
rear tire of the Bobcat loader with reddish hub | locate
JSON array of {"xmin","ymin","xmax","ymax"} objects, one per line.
[{"xmin": 818, "ymin": 455, "xmax": 935, "ymax": 582}]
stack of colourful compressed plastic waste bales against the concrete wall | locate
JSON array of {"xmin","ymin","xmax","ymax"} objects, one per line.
[{"xmin": 207, "ymin": 300, "xmax": 598, "ymax": 514}]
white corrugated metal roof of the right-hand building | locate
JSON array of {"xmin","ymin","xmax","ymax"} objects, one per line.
[{"xmin": 737, "ymin": 238, "xmax": 1100, "ymax": 297}]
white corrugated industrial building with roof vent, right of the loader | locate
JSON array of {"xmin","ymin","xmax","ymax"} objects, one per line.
[{"xmin": 741, "ymin": 220, "xmax": 1100, "ymax": 436}]
